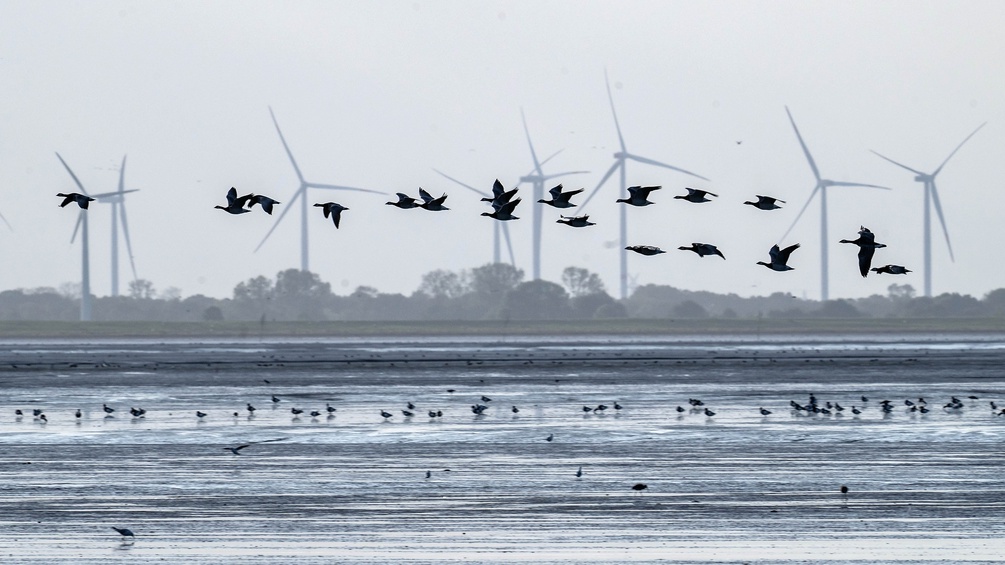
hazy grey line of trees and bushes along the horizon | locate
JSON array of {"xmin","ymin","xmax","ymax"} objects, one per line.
[{"xmin": 0, "ymin": 263, "xmax": 1005, "ymax": 323}]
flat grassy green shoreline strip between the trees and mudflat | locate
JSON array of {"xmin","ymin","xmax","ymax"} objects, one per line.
[{"xmin": 0, "ymin": 318, "xmax": 1005, "ymax": 340}]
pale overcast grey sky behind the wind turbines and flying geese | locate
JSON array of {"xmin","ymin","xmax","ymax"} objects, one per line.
[{"xmin": 0, "ymin": 0, "xmax": 1005, "ymax": 299}]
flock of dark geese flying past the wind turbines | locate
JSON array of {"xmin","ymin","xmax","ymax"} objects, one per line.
[{"xmin": 57, "ymin": 179, "xmax": 911, "ymax": 276}]
